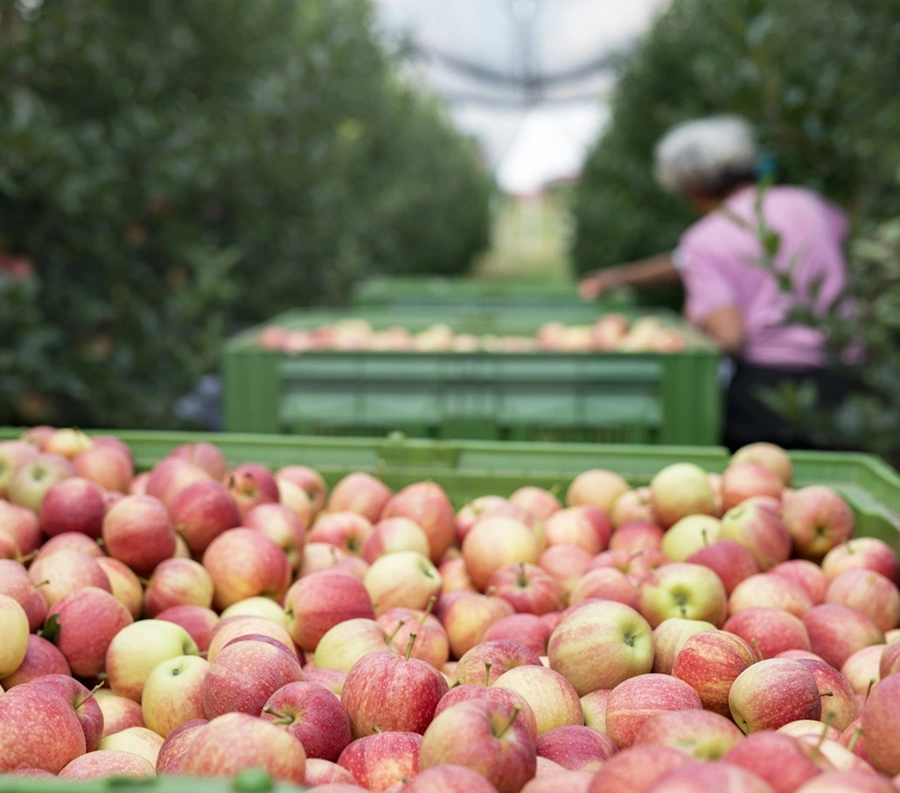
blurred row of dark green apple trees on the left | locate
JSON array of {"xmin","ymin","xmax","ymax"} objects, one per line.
[{"xmin": 0, "ymin": 0, "xmax": 491, "ymax": 427}]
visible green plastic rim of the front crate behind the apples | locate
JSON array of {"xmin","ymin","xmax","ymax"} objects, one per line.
[{"xmin": 0, "ymin": 428, "xmax": 900, "ymax": 554}]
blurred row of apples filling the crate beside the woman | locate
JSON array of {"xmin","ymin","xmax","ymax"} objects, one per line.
[{"xmin": 257, "ymin": 314, "xmax": 696, "ymax": 354}]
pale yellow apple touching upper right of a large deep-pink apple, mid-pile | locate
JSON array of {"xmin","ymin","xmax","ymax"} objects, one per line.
[{"xmin": 363, "ymin": 551, "xmax": 441, "ymax": 615}]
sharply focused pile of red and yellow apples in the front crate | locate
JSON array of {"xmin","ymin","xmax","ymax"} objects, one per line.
[{"xmin": 0, "ymin": 434, "xmax": 900, "ymax": 793}]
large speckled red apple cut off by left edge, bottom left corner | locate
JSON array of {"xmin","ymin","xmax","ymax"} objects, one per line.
[{"xmin": 0, "ymin": 684, "xmax": 85, "ymax": 774}]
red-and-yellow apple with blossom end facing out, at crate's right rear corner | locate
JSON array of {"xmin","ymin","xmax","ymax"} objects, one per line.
[{"xmin": 782, "ymin": 485, "xmax": 854, "ymax": 561}]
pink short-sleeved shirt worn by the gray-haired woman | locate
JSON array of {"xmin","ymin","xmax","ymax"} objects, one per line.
[{"xmin": 675, "ymin": 186, "xmax": 847, "ymax": 367}]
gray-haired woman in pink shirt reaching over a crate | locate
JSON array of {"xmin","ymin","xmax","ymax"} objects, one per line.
[{"xmin": 580, "ymin": 116, "xmax": 848, "ymax": 449}]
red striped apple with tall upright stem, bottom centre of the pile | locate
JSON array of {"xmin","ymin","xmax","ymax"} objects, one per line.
[{"xmin": 341, "ymin": 637, "xmax": 448, "ymax": 738}]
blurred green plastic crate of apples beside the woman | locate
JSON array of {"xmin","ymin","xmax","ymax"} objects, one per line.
[{"xmin": 222, "ymin": 312, "xmax": 721, "ymax": 445}]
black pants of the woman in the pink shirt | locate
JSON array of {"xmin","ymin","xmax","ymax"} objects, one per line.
[{"xmin": 724, "ymin": 362, "xmax": 859, "ymax": 451}]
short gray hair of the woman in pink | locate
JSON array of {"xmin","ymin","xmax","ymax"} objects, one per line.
[{"xmin": 655, "ymin": 116, "xmax": 757, "ymax": 198}]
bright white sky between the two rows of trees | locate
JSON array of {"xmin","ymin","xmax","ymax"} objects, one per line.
[{"xmin": 377, "ymin": 0, "xmax": 668, "ymax": 193}]
